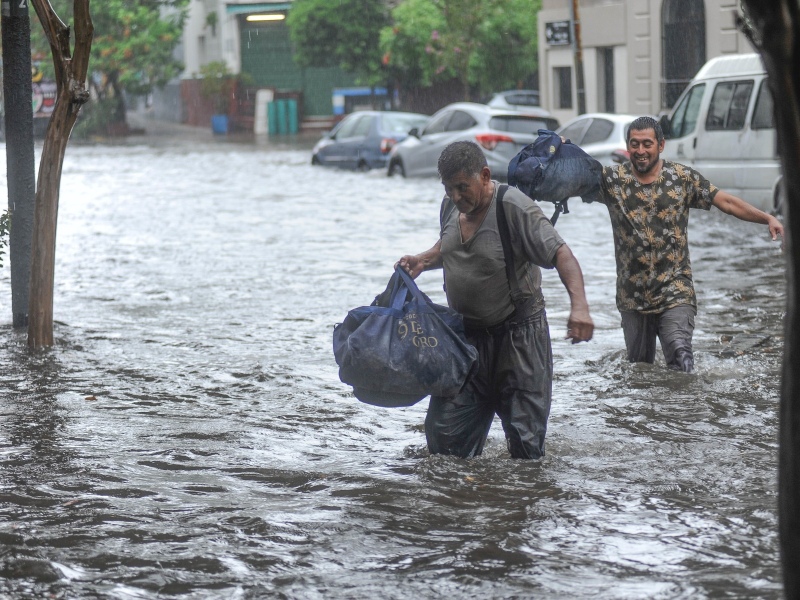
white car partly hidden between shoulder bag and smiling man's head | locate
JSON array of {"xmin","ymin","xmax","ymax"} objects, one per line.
[{"xmin": 556, "ymin": 113, "xmax": 636, "ymax": 166}]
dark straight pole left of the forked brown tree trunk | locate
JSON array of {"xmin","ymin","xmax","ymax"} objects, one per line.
[{"xmin": 2, "ymin": 2, "xmax": 36, "ymax": 328}]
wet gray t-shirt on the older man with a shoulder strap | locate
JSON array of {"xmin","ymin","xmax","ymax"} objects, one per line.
[{"xmin": 440, "ymin": 181, "xmax": 564, "ymax": 327}]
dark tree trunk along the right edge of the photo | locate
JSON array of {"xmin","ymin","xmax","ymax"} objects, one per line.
[{"xmin": 743, "ymin": 0, "xmax": 800, "ymax": 600}]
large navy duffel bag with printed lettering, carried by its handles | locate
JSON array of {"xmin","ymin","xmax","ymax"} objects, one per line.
[{"xmin": 333, "ymin": 267, "xmax": 478, "ymax": 407}]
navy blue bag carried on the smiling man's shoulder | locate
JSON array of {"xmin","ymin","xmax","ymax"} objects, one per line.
[{"xmin": 508, "ymin": 129, "xmax": 603, "ymax": 202}]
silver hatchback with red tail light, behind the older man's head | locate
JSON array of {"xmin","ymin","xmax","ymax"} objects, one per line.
[{"xmin": 388, "ymin": 102, "xmax": 558, "ymax": 178}]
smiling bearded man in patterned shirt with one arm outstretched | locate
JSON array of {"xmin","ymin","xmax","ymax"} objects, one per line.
[{"xmin": 588, "ymin": 117, "xmax": 783, "ymax": 373}]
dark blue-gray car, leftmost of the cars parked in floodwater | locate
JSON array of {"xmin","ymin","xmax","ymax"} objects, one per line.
[{"xmin": 311, "ymin": 111, "xmax": 428, "ymax": 171}]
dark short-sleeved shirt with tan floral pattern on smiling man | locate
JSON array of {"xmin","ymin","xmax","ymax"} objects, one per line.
[{"xmin": 600, "ymin": 160, "xmax": 718, "ymax": 313}]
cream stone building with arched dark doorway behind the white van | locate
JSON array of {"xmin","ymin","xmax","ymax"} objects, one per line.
[{"xmin": 539, "ymin": 0, "xmax": 754, "ymax": 123}]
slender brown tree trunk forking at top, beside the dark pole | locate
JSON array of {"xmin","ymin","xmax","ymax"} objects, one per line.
[{"xmin": 28, "ymin": 0, "xmax": 93, "ymax": 348}]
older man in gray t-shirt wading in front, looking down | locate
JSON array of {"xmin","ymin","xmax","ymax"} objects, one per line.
[{"xmin": 399, "ymin": 142, "xmax": 594, "ymax": 458}]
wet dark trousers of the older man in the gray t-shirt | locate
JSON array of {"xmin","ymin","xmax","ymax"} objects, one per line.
[{"xmin": 425, "ymin": 310, "xmax": 553, "ymax": 458}]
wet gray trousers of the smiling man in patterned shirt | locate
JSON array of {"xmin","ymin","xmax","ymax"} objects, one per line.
[{"xmin": 620, "ymin": 304, "xmax": 697, "ymax": 373}]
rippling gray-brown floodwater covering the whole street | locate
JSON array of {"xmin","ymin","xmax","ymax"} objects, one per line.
[{"xmin": 0, "ymin": 136, "xmax": 785, "ymax": 600}]
